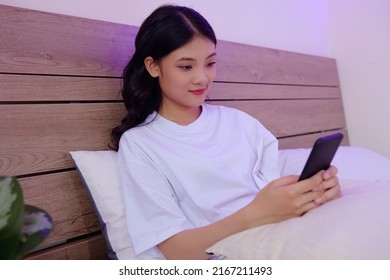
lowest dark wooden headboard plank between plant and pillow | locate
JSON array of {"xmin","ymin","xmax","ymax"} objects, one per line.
[{"xmin": 24, "ymin": 235, "xmax": 108, "ymax": 260}]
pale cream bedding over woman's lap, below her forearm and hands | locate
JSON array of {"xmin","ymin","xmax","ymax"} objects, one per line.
[{"xmin": 208, "ymin": 181, "xmax": 390, "ymax": 260}]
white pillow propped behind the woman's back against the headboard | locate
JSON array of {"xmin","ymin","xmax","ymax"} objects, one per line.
[{"xmin": 70, "ymin": 151, "xmax": 135, "ymax": 260}]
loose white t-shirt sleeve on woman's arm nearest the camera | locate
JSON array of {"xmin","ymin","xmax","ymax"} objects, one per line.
[{"xmin": 118, "ymin": 135, "xmax": 194, "ymax": 255}]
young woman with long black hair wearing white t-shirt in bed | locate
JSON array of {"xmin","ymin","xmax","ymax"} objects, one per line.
[{"xmin": 112, "ymin": 6, "xmax": 340, "ymax": 259}]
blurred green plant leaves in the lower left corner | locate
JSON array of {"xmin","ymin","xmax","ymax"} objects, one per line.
[{"xmin": 0, "ymin": 176, "xmax": 53, "ymax": 260}]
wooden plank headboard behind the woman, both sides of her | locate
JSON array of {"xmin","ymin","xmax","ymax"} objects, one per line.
[{"xmin": 0, "ymin": 5, "xmax": 348, "ymax": 259}]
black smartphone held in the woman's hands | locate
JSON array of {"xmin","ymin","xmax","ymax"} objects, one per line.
[{"xmin": 299, "ymin": 133, "xmax": 344, "ymax": 181}]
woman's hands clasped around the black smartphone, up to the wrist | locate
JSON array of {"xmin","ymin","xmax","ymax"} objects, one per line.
[{"xmin": 243, "ymin": 167, "xmax": 340, "ymax": 228}]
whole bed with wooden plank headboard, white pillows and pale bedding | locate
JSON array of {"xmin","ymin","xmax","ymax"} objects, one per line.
[{"xmin": 0, "ymin": 5, "xmax": 390, "ymax": 259}]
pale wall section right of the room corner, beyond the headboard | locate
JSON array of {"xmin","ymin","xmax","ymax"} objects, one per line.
[{"xmin": 329, "ymin": 0, "xmax": 390, "ymax": 158}]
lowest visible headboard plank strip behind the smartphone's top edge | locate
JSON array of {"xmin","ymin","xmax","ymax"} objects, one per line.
[{"xmin": 279, "ymin": 129, "xmax": 349, "ymax": 149}]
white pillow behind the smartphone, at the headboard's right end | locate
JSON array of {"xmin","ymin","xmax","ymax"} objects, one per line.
[{"xmin": 279, "ymin": 146, "xmax": 390, "ymax": 181}]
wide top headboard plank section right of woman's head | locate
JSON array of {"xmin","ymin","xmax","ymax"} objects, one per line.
[{"xmin": 217, "ymin": 41, "xmax": 339, "ymax": 86}]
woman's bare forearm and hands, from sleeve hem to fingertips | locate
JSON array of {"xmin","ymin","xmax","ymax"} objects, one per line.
[{"xmin": 158, "ymin": 167, "xmax": 340, "ymax": 259}]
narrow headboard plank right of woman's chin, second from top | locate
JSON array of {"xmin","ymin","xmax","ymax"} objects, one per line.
[{"xmin": 208, "ymin": 82, "xmax": 341, "ymax": 100}]
